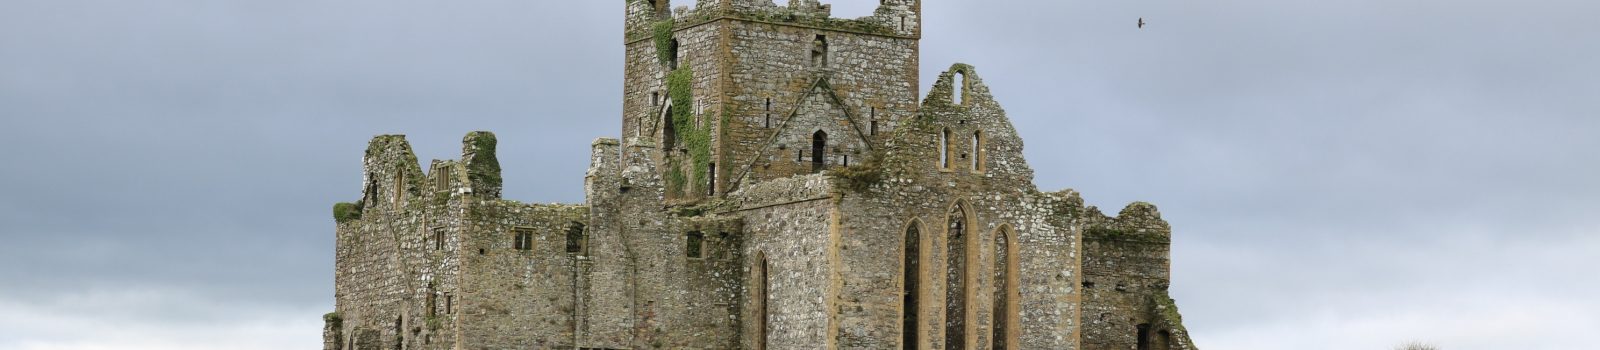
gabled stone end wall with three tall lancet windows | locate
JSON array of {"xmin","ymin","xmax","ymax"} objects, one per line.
[{"xmin": 819, "ymin": 66, "xmax": 1078, "ymax": 348}]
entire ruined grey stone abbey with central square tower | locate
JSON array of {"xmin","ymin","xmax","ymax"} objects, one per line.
[{"xmin": 323, "ymin": 0, "xmax": 1194, "ymax": 350}]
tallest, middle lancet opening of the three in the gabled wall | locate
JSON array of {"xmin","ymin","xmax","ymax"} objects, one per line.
[{"xmin": 944, "ymin": 203, "xmax": 968, "ymax": 348}]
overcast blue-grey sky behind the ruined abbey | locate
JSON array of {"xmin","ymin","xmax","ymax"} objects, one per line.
[{"xmin": 0, "ymin": 0, "xmax": 1600, "ymax": 350}]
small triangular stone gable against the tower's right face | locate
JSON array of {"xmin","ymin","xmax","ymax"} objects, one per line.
[{"xmin": 730, "ymin": 77, "xmax": 872, "ymax": 185}]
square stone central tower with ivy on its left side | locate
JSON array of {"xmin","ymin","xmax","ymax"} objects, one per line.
[{"xmin": 622, "ymin": 0, "xmax": 922, "ymax": 203}]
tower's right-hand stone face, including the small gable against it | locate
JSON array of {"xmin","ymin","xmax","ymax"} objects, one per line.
[{"xmin": 718, "ymin": 10, "xmax": 920, "ymax": 192}]
